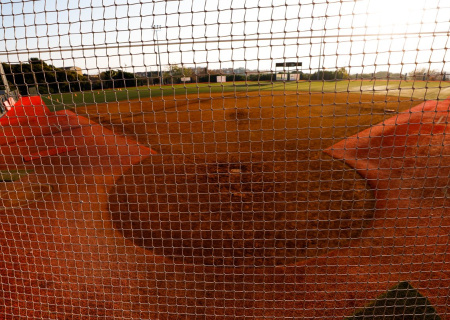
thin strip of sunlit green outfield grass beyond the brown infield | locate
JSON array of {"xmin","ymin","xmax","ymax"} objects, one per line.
[{"xmin": 42, "ymin": 80, "xmax": 450, "ymax": 110}]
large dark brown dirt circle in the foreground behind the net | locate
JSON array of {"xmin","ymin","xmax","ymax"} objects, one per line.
[{"xmin": 110, "ymin": 153, "xmax": 375, "ymax": 266}]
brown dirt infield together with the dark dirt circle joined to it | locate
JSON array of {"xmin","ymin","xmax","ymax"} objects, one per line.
[{"xmin": 76, "ymin": 92, "xmax": 419, "ymax": 266}]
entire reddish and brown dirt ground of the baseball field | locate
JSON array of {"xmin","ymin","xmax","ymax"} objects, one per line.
[{"xmin": 0, "ymin": 84, "xmax": 450, "ymax": 319}]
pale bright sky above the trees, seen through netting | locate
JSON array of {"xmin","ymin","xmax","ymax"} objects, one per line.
[{"xmin": 0, "ymin": 0, "xmax": 450, "ymax": 74}]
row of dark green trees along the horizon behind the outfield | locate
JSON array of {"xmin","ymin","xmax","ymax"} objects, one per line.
[{"xmin": 0, "ymin": 58, "xmax": 349, "ymax": 95}]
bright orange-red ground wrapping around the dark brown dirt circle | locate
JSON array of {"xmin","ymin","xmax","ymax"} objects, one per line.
[{"xmin": 0, "ymin": 97, "xmax": 450, "ymax": 319}]
